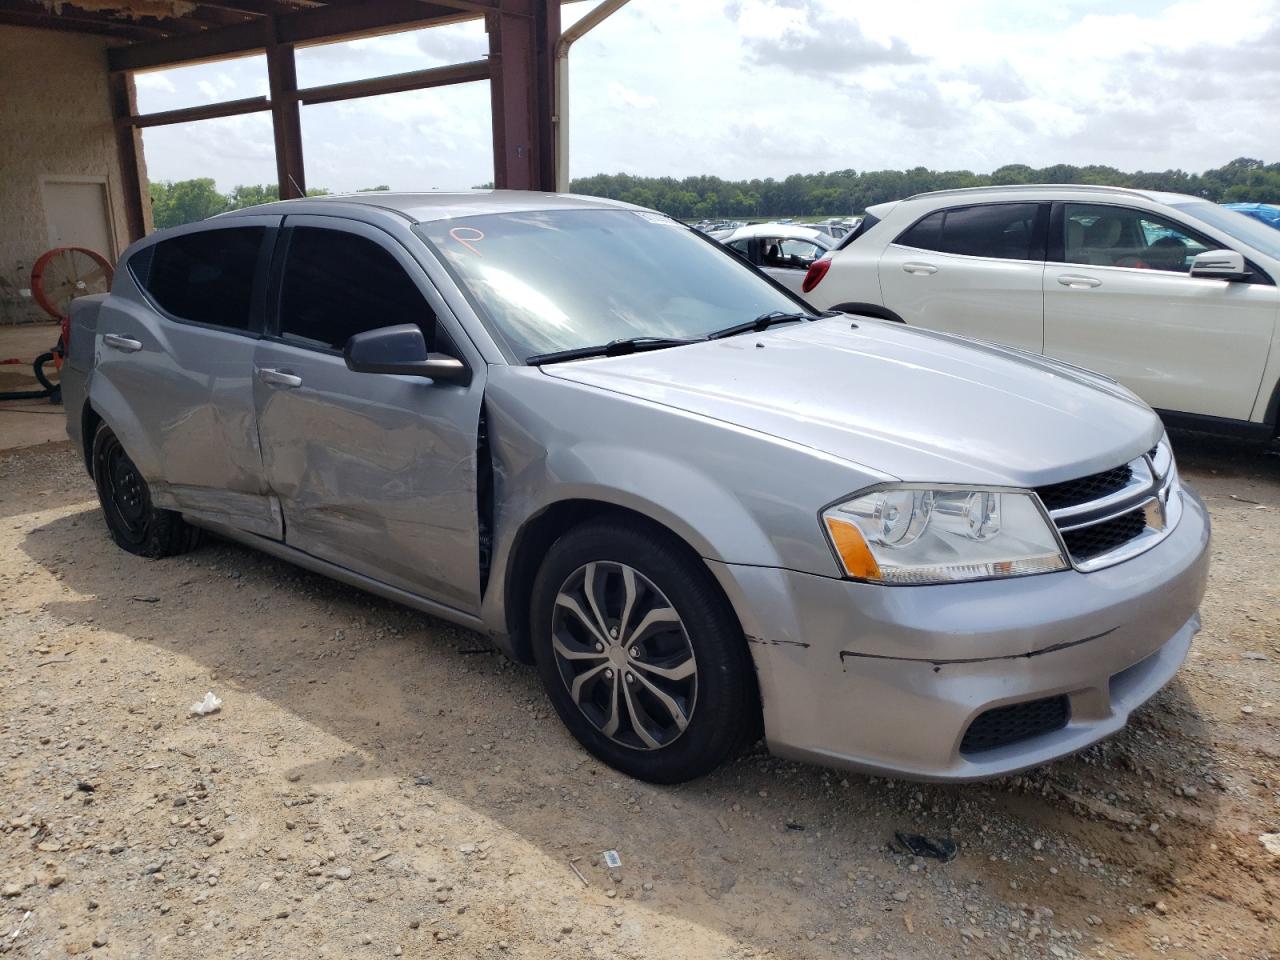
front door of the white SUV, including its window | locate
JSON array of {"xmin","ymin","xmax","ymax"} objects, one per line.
[{"xmin": 1044, "ymin": 204, "xmax": 1280, "ymax": 420}]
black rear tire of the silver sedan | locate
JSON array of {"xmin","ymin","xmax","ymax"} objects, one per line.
[{"xmin": 92, "ymin": 424, "xmax": 200, "ymax": 559}]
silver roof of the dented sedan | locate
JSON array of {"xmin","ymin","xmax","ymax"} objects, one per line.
[{"xmin": 219, "ymin": 189, "xmax": 644, "ymax": 223}]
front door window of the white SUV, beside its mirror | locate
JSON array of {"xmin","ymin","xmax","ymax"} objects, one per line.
[{"xmin": 1064, "ymin": 204, "xmax": 1210, "ymax": 273}]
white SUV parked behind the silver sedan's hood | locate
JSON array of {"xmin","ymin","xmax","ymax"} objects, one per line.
[{"xmin": 801, "ymin": 186, "xmax": 1280, "ymax": 438}]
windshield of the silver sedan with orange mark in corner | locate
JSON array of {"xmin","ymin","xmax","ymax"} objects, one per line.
[{"xmin": 413, "ymin": 210, "xmax": 804, "ymax": 361}]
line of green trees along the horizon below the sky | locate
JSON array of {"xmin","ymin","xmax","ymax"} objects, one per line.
[{"xmin": 151, "ymin": 157, "xmax": 1280, "ymax": 227}]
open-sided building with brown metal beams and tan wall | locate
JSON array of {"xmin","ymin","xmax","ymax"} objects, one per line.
[{"xmin": 0, "ymin": 0, "xmax": 570, "ymax": 321}]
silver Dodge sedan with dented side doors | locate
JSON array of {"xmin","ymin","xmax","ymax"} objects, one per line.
[{"xmin": 63, "ymin": 192, "xmax": 1210, "ymax": 782}]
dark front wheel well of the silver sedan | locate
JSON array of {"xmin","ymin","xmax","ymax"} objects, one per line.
[{"xmin": 506, "ymin": 500, "xmax": 737, "ymax": 663}]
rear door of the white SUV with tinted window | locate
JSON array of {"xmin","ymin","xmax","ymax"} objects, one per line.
[{"xmin": 879, "ymin": 202, "xmax": 1048, "ymax": 353}]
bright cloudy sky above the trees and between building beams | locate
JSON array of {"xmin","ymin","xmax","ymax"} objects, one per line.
[{"xmin": 129, "ymin": 0, "xmax": 1280, "ymax": 191}]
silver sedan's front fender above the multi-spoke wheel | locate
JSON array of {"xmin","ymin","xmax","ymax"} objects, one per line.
[{"xmin": 484, "ymin": 367, "xmax": 882, "ymax": 655}]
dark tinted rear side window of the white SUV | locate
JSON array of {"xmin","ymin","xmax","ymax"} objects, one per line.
[{"xmin": 897, "ymin": 204, "xmax": 1043, "ymax": 260}]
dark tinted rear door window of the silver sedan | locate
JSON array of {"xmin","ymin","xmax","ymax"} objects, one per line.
[{"xmin": 129, "ymin": 227, "xmax": 266, "ymax": 330}]
